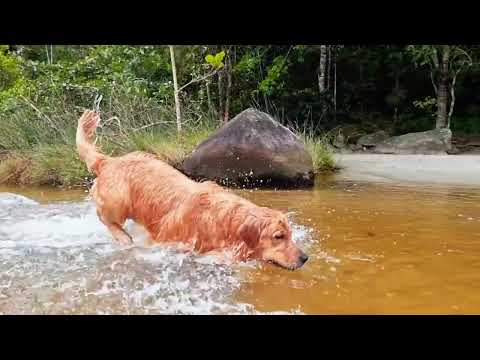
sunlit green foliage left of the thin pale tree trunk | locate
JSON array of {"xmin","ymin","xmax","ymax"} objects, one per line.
[{"xmin": 0, "ymin": 45, "xmax": 172, "ymax": 112}]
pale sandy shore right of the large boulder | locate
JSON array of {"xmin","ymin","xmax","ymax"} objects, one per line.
[{"xmin": 335, "ymin": 154, "xmax": 480, "ymax": 187}]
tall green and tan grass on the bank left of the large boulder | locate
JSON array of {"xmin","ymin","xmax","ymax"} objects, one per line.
[{"xmin": 0, "ymin": 96, "xmax": 215, "ymax": 186}]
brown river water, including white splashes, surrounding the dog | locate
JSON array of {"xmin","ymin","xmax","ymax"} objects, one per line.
[{"xmin": 0, "ymin": 177, "xmax": 480, "ymax": 314}]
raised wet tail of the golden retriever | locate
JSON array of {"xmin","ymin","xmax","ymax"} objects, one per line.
[{"xmin": 76, "ymin": 110, "xmax": 108, "ymax": 175}]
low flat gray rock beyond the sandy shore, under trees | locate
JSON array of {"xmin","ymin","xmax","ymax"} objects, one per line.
[{"xmin": 373, "ymin": 129, "xmax": 452, "ymax": 155}]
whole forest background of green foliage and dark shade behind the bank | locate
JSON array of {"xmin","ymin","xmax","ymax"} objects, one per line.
[{"xmin": 0, "ymin": 45, "xmax": 480, "ymax": 134}]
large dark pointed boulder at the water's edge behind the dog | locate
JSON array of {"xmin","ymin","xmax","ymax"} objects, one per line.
[{"xmin": 182, "ymin": 108, "xmax": 313, "ymax": 187}]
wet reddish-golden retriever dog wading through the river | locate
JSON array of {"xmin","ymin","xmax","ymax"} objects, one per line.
[{"xmin": 76, "ymin": 110, "xmax": 308, "ymax": 270}]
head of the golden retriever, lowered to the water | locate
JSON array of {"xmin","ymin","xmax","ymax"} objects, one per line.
[{"xmin": 240, "ymin": 208, "xmax": 308, "ymax": 270}]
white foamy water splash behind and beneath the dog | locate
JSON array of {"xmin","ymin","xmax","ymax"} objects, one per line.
[{"xmin": 0, "ymin": 194, "xmax": 316, "ymax": 314}]
